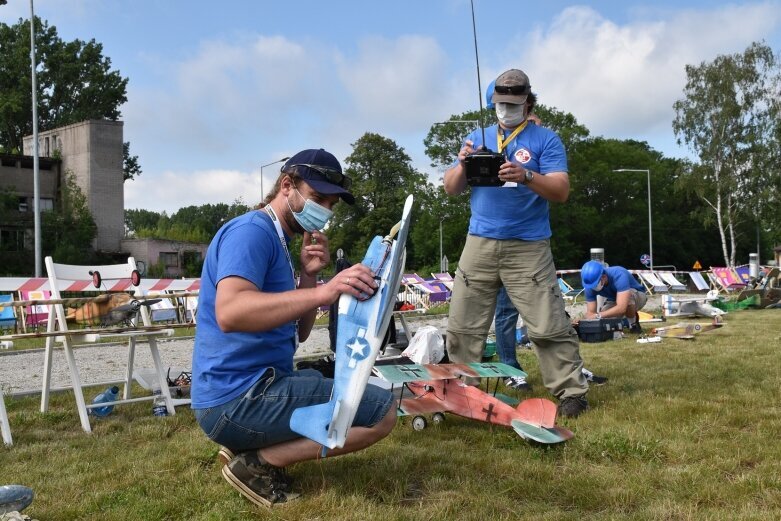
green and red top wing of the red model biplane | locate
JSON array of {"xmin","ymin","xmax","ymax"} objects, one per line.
[{"xmin": 374, "ymin": 362, "xmax": 527, "ymax": 384}]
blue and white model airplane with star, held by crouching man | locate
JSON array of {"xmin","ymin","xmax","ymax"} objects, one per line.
[{"xmin": 290, "ymin": 195, "xmax": 413, "ymax": 452}]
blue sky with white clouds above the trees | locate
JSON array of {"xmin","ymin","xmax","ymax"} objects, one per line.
[{"xmin": 0, "ymin": 0, "xmax": 781, "ymax": 215}]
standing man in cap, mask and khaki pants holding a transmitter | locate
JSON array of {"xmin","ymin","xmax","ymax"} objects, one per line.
[{"xmin": 444, "ymin": 69, "xmax": 588, "ymax": 417}]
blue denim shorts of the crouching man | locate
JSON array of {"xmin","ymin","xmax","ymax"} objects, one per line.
[{"xmin": 194, "ymin": 369, "xmax": 393, "ymax": 452}]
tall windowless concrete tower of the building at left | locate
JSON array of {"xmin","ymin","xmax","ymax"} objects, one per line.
[{"xmin": 21, "ymin": 120, "xmax": 125, "ymax": 253}]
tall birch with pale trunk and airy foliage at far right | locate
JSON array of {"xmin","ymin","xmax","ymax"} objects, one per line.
[{"xmin": 673, "ymin": 42, "xmax": 781, "ymax": 266}]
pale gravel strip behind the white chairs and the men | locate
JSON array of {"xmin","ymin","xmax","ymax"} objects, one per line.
[{"xmin": 0, "ymin": 296, "xmax": 660, "ymax": 394}]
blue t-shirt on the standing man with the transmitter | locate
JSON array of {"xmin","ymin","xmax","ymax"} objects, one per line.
[{"xmin": 458, "ymin": 123, "xmax": 567, "ymax": 241}]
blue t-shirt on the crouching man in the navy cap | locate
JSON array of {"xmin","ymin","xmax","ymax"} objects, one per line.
[{"xmin": 191, "ymin": 211, "xmax": 296, "ymax": 409}]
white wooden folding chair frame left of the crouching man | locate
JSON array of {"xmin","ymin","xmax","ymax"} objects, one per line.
[{"xmin": 41, "ymin": 257, "xmax": 176, "ymax": 432}]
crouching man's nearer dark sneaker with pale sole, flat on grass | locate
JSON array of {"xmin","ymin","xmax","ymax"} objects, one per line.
[{"xmin": 222, "ymin": 451, "xmax": 300, "ymax": 507}]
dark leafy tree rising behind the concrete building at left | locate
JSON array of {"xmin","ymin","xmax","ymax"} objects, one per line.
[{"xmin": 0, "ymin": 17, "xmax": 127, "ymax": 152}]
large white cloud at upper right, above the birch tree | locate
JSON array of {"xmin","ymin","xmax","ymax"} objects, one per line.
[{"xmin": 523, "ymin": 3, "xmax": 781, "ymax": 137}]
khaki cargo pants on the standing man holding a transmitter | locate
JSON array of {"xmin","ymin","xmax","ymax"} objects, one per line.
[{"xmin": 447, "ymin": 235, "xmax": 588, "ymax": 399}]
